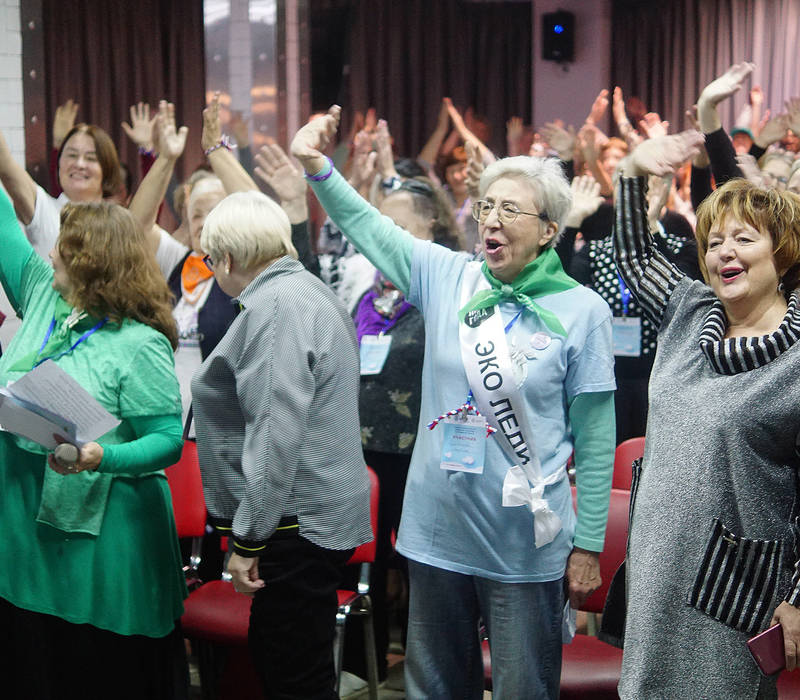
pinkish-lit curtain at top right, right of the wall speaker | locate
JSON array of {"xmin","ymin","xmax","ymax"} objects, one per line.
[{"xmin": 612, "ymin": 0, "xmax": 800, "ymax": 133}]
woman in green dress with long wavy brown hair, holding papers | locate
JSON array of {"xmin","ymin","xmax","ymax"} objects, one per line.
[{"xmin": 0, "ymin": 190, "xmax": 186, "ymax": 700}]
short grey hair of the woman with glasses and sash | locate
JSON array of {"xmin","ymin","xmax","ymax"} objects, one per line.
[{"xmin": 479, "ymin": 156, "xmax": 572, "ymax": 248}]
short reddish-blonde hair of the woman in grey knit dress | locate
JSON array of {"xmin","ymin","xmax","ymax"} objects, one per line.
[{"xmin": 695, "ymin": 178, "xmax": 800, "ymax": 292}]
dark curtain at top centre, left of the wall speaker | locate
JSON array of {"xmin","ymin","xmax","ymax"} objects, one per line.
[{"xmin": 340, "ymin": 0, "xmax": 532, "ymax": 156}]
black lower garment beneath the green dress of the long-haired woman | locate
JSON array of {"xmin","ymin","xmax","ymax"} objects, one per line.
[{"xmin": 0, "ymin": 598, "xmax": 189, "ymax": 700}]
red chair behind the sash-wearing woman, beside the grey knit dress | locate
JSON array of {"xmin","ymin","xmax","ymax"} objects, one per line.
[{"xmin": 482, "ymin": 486, "xmax": 630, "ymax": 700}]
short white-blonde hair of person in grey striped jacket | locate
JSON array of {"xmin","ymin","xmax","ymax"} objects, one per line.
[{"xmin": 200, "ymin": 190, "xmax": 297, "ymax": 269}]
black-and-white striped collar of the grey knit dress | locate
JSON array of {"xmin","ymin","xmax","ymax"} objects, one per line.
[{"xmin": 700, "ymin": 292, "xmax": 800, "ymax": 374}]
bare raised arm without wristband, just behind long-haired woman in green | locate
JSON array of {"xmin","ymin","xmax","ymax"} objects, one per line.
[{"xmin": 129, "ymin": 100, "xmax": 189, "ymax": 255}]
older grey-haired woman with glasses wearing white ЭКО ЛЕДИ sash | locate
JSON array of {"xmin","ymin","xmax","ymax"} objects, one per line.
[{"xmin": 292, "ymin": 107, "xmax": 614, "ymax": 698}]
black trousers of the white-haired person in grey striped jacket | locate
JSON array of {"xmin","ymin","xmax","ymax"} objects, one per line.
[{"xmin": 249, "ymin": 536, "xmax": 353, "ymax": 700}]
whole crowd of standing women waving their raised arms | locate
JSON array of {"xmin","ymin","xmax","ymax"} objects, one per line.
[{"xmin": 0, "ymin": 57, "xmax": 800, "ymax": 700}]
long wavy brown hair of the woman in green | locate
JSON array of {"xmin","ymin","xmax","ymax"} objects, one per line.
[{"xmin": 56, "ymin": 202, "xmax": 178, "ymax": 349}]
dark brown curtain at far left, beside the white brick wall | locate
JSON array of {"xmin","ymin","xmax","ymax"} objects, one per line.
[{"xmin": 42, "ymin": 0, "xmax": 205, "ymax": 185}]
